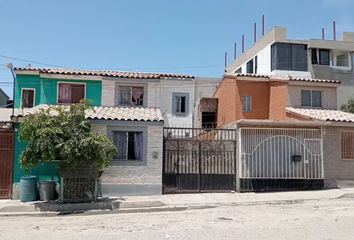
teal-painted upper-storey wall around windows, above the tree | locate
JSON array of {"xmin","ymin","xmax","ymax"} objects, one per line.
[{"xmin": 15, "ymin": 74, "xmax": 102, "ymax": 108}]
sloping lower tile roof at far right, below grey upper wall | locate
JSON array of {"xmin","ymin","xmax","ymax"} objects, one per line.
[{"xmin": 286, "ymin": 107, "xmax": 354, "ymax": 123}]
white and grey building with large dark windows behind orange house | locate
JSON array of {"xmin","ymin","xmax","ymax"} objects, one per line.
[{"xmin": 225, "ymin": 26, "xmax": 354, "ymax": 108}]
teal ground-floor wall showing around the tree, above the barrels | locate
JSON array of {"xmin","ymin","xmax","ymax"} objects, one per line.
[{"xmin": 12, "ymin": 123, "xmax": 59, "ymax": 183}]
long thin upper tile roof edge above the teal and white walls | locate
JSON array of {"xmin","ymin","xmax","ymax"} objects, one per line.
[{"xmin": 14, "ymin": 67, "xmax": 194, "ymax": 79}]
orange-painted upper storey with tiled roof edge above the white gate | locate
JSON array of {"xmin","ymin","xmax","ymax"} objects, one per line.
[{"xmin": 213, "ymin": 73, "xmax": 340, "ymax": 126}]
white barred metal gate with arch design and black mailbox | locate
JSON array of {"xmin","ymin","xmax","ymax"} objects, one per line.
[{"xmin": 238, "ymin": 128, "xmax": 324, "ymax": 190}]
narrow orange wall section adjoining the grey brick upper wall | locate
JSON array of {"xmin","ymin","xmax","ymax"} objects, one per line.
[{"xmin": 269, "ymin": 82, "xmax": 288, "ymax": 120}]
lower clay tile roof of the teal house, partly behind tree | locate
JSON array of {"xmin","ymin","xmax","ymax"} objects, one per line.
[{"xmin": 15, "ymin": 104, "xmax": 163, "ymax": 122}]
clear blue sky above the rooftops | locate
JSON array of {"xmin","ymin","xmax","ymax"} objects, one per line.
[{"xmin": 0, "ymin": 0, "xmax": 354, "ymax": 97}]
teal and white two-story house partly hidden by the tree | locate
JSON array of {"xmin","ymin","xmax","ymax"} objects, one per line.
[{"xmin": 9, "ymin": 67, "xmax": 194, "ymax": 198}]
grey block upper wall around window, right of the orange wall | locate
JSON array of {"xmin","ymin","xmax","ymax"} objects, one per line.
[{"xmin": 287, "ymin": 84, "xmax": 337, "ymax": 110}]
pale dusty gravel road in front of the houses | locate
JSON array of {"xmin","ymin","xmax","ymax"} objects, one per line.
[{"xmin": 0, "ymin": 199, "xmax": 354, "ymax": 240}]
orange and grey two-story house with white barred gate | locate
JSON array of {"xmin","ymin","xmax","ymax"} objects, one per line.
[{"xmin": 213, "ymin": 73, "xmax": 354, "ymax": 191}]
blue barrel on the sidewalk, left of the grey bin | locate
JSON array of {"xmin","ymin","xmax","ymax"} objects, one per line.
[{"xmin": 20, "ymin": 176, "xmax": 38, "ymax": 202}]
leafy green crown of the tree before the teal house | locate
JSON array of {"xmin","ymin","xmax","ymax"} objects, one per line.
[{"xmin": 19, "ymin": 100, "xmax": 118, "ymax": 173}]
